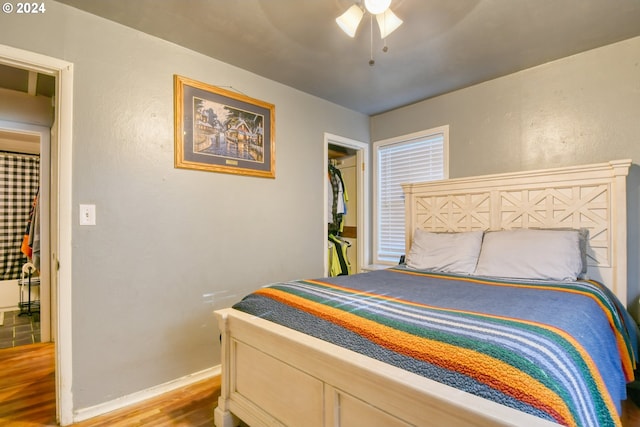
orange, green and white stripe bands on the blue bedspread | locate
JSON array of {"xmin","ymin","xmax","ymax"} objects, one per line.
[{"xmin": 245, "ymin": 270, "xmax": 635, "ymax": 426}]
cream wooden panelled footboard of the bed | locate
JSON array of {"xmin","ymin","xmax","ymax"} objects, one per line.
[{"xmin": 215, "ymin": 309, "xmax": 557, "ymax": 427}]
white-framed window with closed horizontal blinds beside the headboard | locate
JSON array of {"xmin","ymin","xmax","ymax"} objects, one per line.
[{"xmin": 373, "ymin": 126, "xmax": 449, "ymax": 264}]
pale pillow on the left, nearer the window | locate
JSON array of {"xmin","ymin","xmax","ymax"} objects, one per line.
[{"xmin": 407, "ymin": 229, "xmax": 483, "ymax": 274}]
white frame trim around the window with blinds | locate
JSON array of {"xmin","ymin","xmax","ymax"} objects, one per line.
[{"xmin": 371, "ymin": 125, "xmax": 449, "ymax": 265}]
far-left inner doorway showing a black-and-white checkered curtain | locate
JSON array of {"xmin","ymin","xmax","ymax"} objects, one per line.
[{"xmin": 0, "ymin": 120, "xmax": 55, "ymax": 347}]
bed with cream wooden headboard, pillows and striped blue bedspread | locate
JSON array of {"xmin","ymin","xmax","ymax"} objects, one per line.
[{"xmin": 215, "ymin": 160, "xmax": 637, "ymax": 427}]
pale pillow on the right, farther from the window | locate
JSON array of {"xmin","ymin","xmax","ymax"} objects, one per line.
[{"xmin": 475, "ymin": 229, "xmax": 582, "ymax": 280}]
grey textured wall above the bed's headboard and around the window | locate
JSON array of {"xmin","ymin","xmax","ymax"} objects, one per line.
[{"xmin": 371, "ymin": 37, "xmax": 640, "ymax": 308}]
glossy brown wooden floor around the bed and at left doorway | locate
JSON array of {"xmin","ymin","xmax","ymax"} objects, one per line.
[{"xmin": 0, "ymin": 343, "xmax": 640, "ymax": 427}]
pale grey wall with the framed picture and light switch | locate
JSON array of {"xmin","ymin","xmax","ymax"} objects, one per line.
[{"xmin": 0, "ymin": 1, "xmax": 369, "ymax": 410}]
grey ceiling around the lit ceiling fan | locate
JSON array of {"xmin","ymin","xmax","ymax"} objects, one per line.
[{"xmin": 52, "ymin": 0, "xmax": 640, "ymax": 115}]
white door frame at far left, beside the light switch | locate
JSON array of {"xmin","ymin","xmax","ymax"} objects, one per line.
[{"xmin": 0, "ymin": 45, "xmax": 73, "ymax": 425}]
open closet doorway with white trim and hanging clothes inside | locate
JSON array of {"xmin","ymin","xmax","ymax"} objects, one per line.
[{"xmin": 323, "ymin": 133, "xmax": 370, "ymax": 276}]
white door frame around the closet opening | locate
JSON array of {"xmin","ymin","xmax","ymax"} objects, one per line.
[{"xmin": 322, "ymin": 132, "xmax": 371, "ymax": 276}]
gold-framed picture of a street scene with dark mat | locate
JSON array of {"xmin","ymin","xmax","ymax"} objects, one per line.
[{"xmin": 174, "ymin": 75, "xmax": 276, "ymax": 178}]
